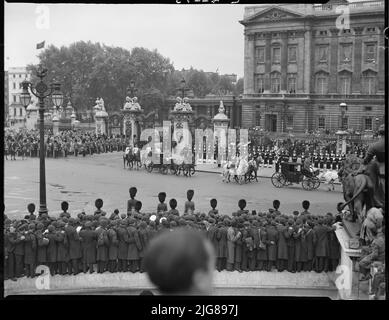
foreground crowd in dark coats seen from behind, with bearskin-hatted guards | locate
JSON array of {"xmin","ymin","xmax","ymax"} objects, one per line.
[{"xmin": 4, "ymin": 190, "xmax": 339, "ymax": 280}]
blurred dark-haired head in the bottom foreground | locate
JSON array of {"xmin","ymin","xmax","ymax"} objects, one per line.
[{"xmin": 144, "ymin": 229, "xmax": 215, "ymax": 295}]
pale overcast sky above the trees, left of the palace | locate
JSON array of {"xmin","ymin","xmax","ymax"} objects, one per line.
[{"xmin": 4, "ymin": 3, "xmax": 245, "ymax": 77}]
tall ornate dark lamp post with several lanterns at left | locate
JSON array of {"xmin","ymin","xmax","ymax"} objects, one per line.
[{"xmin": 20, "ymin": 65, "xmax": 63, "ymax": 215}]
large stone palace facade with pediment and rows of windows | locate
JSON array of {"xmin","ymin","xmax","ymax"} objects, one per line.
[{"xmin": 240, "ymin": 0, "xmax": 385, "ymax": 132}]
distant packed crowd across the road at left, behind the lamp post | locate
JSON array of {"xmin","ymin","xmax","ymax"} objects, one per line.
[{"xmin": 4, "ymin": 131, "xmax": 129, "ymax": 160}]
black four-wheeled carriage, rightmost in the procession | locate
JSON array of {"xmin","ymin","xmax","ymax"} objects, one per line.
[{"xmin": 271, "ymin": 162, "xmax": 320, "ymax": 190}]
